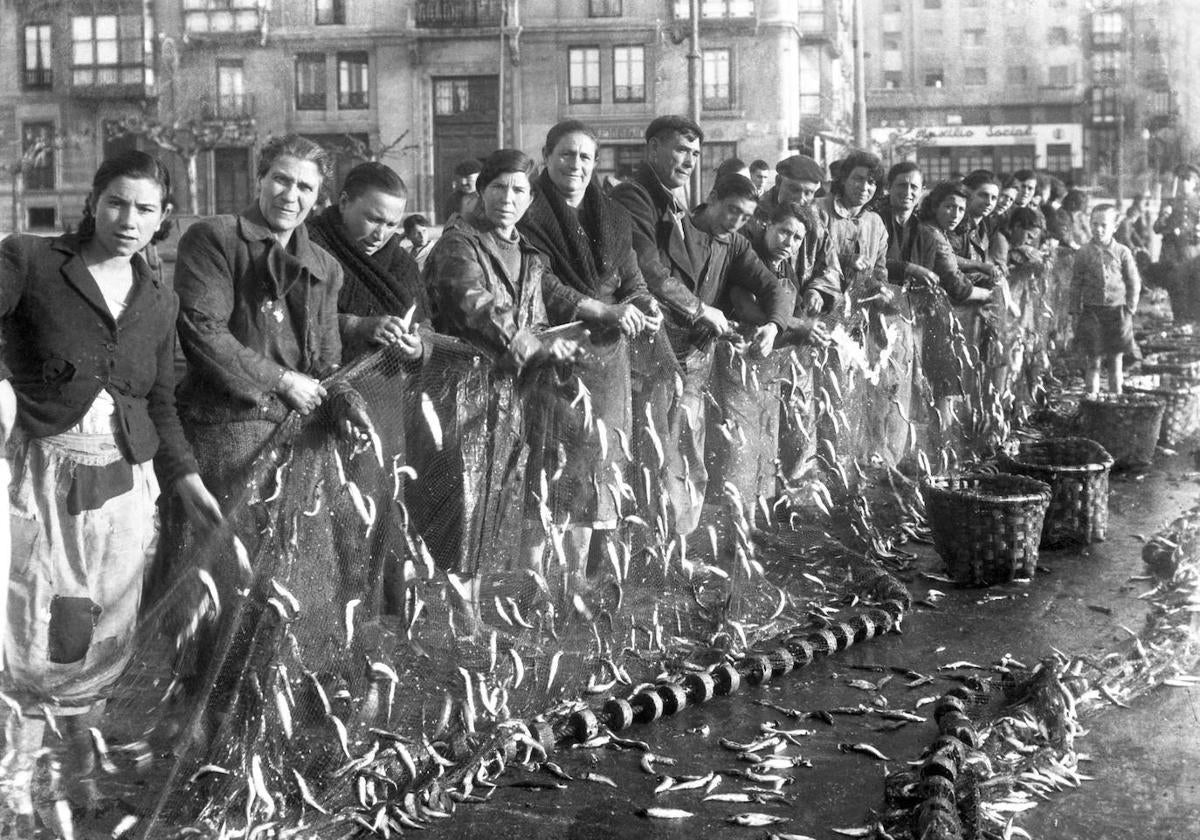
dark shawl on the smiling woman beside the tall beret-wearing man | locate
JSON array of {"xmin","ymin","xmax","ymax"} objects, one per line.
[{"xmin": 517, "ymin": 170, "xmax": 630, "ymax": 296}]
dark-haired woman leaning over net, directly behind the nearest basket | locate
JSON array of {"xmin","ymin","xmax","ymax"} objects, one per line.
[{"xmin": 904, "ymin": 181, "xmax": 991, "ymax": 443}]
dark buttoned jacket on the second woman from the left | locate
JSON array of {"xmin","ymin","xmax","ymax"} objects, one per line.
[{"xmin": 175, "ymin": 205, "xmax": 342, "ymax": 422}]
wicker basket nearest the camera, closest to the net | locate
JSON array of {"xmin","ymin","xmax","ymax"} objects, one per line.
[{"xmin": 922, "ymin": 473, "xmax": 1050, "ymax": 587}]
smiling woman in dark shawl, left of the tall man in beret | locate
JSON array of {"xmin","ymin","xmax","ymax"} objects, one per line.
[{"xmin": 517, "ymin": 120, "xmax": 661, "ymax": 589}]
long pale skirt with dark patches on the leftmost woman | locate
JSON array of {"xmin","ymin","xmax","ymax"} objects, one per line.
[{"xmin": 4, "ymin": 433, "xmax": 158, "ymax": 715}]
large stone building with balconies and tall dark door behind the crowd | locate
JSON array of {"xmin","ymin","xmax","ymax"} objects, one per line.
[{"xmin": 0, "ymin": 0, "xmax": 852, "ymax": 229}]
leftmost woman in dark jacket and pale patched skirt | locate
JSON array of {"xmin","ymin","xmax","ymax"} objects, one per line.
[{"xmin": 0, "ymin": 151, "xmax": 221, "ymax": 818}]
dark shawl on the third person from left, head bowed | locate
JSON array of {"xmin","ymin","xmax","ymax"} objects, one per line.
[{"xmin": 308, "ymin": 205, "xmax": 430, "ymax": 324}]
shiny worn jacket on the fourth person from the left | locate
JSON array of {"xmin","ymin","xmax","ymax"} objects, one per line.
[{"xmin": 425, "ymin": 206, "xmax": 546, "ymax": 370}]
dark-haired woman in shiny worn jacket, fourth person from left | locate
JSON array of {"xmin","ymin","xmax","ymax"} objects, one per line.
[{"xmin": 410, "ymin": 149, "xmax": 576, "ymax": 631}]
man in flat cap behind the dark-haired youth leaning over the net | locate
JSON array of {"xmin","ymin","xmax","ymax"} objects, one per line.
[{"xmin": 743, "ymin": 155, "xmax": 842, "ymax": 316}]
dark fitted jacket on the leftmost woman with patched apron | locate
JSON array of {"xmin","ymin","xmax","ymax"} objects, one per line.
[{"xmin": 0, "ymin": 235, "xmax": 197, "ymax": 486}]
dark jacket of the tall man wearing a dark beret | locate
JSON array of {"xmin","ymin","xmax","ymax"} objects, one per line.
[{"xmin": 612, "ymin": 163, "xmax": 704, "ymax": 324}]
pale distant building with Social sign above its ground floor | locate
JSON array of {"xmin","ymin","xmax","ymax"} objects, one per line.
[{"xmin": 862, "ymin": 0, "xmax": 1086, "ymax": 181}]
